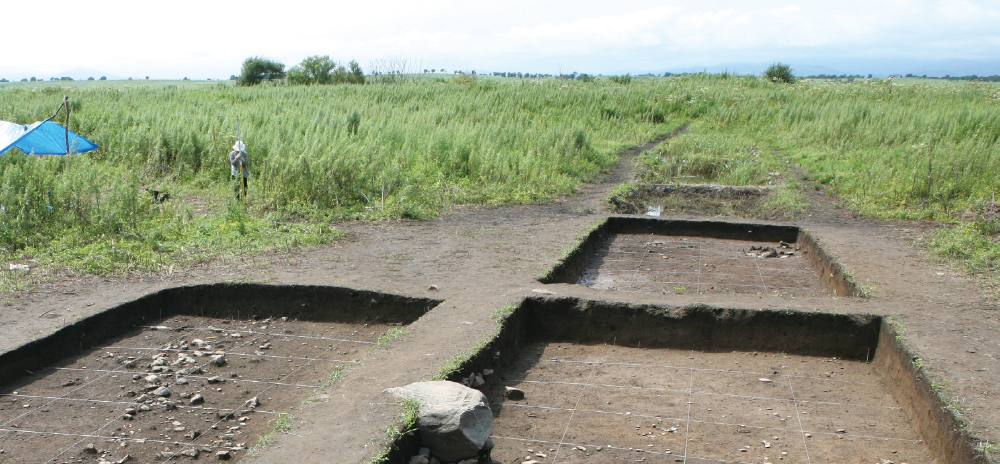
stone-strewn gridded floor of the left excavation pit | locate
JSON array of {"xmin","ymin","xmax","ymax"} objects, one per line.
[{"xmin": 0, "ymin": 316, "xmax": 387, "ymax": 464}]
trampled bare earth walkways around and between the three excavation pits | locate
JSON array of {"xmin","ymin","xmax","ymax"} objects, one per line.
[{"xmin": 0, "ymin": 131, "xmax": 1000, "ymax": 464}]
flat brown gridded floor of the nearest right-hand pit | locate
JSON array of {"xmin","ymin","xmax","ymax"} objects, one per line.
[{"xmin": 488, "ymin": 343, "xmax": 934, "ymax": 464}]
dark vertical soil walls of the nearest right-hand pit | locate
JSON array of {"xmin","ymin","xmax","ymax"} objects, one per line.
[{"xmin": 380, "ymin": 297, "xmax": 992, "ymax": 464}]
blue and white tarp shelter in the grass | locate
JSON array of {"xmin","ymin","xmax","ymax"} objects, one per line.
[{"xmin": 0, "ymin": 121, "xmax": 100, "ymax": 155}]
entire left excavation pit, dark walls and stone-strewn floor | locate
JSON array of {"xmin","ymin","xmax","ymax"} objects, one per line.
[{"xmin": 0, "ymin": 284, "xmax": 440, "ymax": 464}]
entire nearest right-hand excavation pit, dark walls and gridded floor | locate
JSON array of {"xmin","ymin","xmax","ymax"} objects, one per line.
[{"xmin": 388, "ymin": 297, "xmax": 987, "ymax": 464}]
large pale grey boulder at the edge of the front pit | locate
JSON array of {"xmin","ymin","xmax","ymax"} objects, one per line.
[{"xmin": 386, "ymin": 381, "xmax": 493, "ymax": 462}]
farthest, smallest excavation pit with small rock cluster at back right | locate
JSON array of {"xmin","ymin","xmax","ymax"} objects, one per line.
[{"xmin": 539, "ymin": 216, "xmax": 860, "ymax": 297}]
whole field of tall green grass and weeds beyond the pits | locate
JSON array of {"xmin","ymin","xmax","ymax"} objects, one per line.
[{"xmin": 0, "ymin": 75, "xmax": 1000, "ymax": 288}]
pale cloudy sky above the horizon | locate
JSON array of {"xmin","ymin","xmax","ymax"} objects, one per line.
[{"xmin": 0, "ymin": 0, "xmax": 1000, "ymax": 79}]
